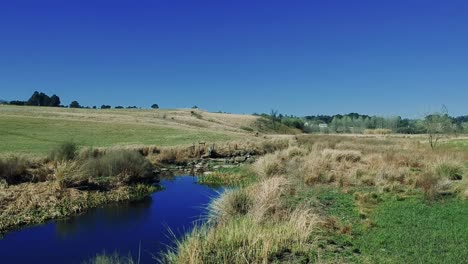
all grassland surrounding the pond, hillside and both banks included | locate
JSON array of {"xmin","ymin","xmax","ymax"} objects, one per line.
[{"xmin": 0, "ymin": 106, "xmax": 468, "ymax": 264}]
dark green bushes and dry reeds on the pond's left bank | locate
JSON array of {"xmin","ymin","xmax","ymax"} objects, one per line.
[{"xmin": 0, "ymin": 143, "xmax": 158, "ymax": 233}]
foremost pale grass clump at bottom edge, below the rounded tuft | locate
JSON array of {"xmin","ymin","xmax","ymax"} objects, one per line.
[{"xmin": 161, "ymin": 208, "xmax": 319, "ymax": 264}]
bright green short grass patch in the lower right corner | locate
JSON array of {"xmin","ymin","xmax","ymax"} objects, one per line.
[{"xmin": 306, "ymin": 188, "xmax": 468, "ymax": 263}]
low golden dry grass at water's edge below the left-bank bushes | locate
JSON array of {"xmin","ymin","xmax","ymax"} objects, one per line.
[{"xmin": 0, "ymin": 182, "xmax": 155, "ymax": 233}]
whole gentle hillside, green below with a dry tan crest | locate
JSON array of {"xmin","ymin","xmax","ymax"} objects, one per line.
[{"xmin": 0, "ymin": 106, "xmax": 260, "ymax": 154}]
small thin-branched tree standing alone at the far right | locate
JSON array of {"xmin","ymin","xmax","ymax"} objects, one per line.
[{"xmin": 424, "ymin": 107, "xmax": 453, "ymax": 150}]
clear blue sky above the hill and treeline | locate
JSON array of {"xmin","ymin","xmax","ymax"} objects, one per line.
[{"xmin": 0, "ymin": 0, "xmax": 468, "ymax": 117}]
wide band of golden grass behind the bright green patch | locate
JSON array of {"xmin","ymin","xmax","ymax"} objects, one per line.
[{"xmin": 254, "ymin": 137, "xmax": 465, "ymax": 197}]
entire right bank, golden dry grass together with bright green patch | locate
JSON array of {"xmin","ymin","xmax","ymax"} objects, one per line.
[{"xmin": 165, "ymin": 136, "xmax": 468, "ymax": 263}]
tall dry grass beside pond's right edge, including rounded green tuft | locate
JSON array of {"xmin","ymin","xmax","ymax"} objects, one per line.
[{"xmin": 161, "ymin": 172, "xmax": 319, "ymax": 263}]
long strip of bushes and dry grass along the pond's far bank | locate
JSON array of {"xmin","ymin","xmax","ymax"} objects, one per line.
[{"xmin": 0, "ymin": 138, "xmax": 288, "ymax": 233}]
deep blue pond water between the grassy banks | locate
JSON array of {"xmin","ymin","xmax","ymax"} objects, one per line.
[{"xmin": 0, "ymin": 176, "xmax": 220, "ymax": 263}]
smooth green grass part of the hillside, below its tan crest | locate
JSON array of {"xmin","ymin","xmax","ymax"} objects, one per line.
[{"xmin": 0, "ymin": 109, "xmax": 235, "ymax": 155}]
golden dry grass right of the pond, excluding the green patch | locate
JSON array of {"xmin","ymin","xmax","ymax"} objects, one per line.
[{"xmin": 164, "ymin": 136, "xmax": 468, "ymax": 263}]
